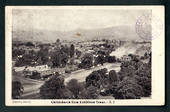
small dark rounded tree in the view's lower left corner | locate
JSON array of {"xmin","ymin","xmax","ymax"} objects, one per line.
[{"xmin": 12, "ymin": 81, "xmax": 24, "ymax": 99}]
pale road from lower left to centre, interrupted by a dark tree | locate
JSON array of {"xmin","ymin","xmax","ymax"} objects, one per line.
[{"xmin": 13, "ymin": 63, "xmax": 120, "ymax": 99}]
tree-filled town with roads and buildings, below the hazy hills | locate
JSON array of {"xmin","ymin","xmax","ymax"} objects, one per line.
[{"xmin": 12, "ymin": 38, "xmax": 151, "ymax": 99}]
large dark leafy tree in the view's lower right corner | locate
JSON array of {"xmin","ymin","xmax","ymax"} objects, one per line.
[{"xmin": 113, "ymin": 60, "xmax": 151, "ymax": 99}]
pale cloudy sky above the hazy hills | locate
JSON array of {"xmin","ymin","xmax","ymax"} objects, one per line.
[{"xmin": 12, "ymin": 8, "xmax": 151, "ymax": 31}]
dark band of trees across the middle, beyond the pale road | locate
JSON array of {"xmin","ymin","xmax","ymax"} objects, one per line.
[{"xmin": 12, "ymin": 39, "xmax": 116, "ymax": 69}]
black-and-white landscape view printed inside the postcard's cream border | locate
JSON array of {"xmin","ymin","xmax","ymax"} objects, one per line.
[{"xmin": 12, "ymin": 9, "xmax": 152, "ymax": 99}]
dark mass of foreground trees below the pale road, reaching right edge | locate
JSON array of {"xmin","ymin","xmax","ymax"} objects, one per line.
[{"xmin": 37, "ymin": 56, "xmax": 151, "ymax": 99}]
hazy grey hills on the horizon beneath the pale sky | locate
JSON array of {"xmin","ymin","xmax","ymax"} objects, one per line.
[{"xmin": 12, "ymin": 26, "xmax": 144, "ymax": 42}]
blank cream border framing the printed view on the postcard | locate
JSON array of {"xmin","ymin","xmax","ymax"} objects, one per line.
[{"xmin": 5, "ymin": 6, "xmax": 165, "ymax": 106}]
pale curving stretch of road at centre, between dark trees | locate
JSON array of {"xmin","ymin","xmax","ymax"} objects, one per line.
[{"xmin": 65, "ymin": 63, "xmax": 120, "ymax": 84}]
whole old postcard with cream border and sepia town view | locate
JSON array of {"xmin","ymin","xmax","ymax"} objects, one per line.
[{"xmin": 5, "ymin": 6, "xmax": 165, "ymax": 106}]
